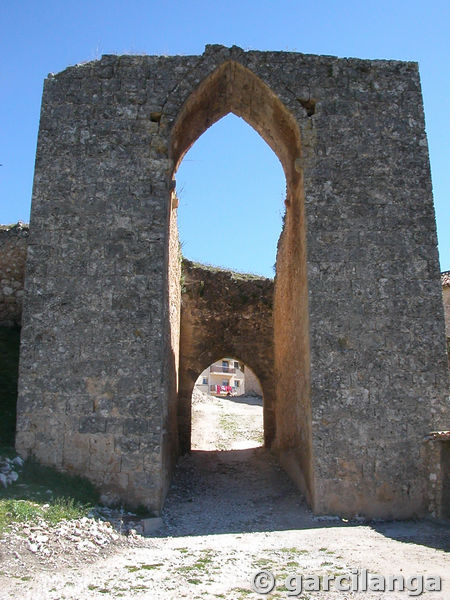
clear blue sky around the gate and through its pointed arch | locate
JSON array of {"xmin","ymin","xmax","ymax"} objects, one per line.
[{"xmin": 0, "ymin": 0, "xmax": 450, "ymax": 276}]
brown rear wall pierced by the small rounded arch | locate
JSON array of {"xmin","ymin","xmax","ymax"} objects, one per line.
[{"xmin": 179, "ymin": 259, "xmax": 275, "ymax": 451}]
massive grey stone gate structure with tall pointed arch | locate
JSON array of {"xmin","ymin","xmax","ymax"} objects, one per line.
[{"xmin": 17, "ymin": 46, "xmax": 448, "ymax": 517}]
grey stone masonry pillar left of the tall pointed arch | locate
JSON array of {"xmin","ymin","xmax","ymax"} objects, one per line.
[{"xmin": 16, "ymin": 57, "xmax": 176, "ymax": 512}]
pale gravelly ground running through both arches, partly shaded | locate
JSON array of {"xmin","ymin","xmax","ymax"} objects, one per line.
[{"xmin": 0, "ymin": 398, "xmax": 450, "ymax": 600}]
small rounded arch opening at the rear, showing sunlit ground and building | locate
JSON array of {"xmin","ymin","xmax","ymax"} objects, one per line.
[{"xmin": 191, "ymin": 356, "xmax": 264, "ymax": 451}]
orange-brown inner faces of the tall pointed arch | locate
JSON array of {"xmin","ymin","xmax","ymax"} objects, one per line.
[{"xmin": 169, "ymin": 60, "xmax": 313, "ymax": 502}]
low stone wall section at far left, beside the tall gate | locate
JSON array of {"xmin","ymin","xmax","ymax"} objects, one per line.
[{"xmin": 0, "ymin": 221, "xmax": 29, "ymax": 327}]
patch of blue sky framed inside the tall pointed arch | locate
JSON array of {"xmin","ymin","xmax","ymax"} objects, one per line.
[{"xmin": 176, "ymin": 113, "xmax": 286, "ymax": 278}]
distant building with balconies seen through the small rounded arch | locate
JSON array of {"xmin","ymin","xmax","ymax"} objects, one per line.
[{"xmin": 195, "ymin": 357, "xmax": 262, "ymax": 396}]
